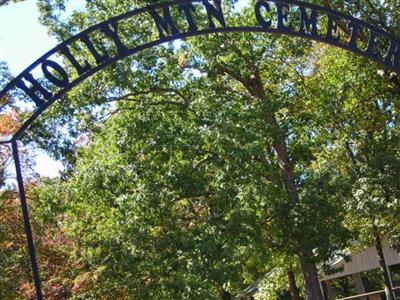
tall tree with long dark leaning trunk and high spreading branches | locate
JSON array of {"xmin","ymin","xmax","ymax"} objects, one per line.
[{"xmin": 12, "ymin": 1, "xmax": 396, "ymax": 299}]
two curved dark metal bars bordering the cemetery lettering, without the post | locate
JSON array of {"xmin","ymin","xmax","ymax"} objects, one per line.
[{"xmin": 0, "ymin": 0, "xmax": 400, "ymax": 143}]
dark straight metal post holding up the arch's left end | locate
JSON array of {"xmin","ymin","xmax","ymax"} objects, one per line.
[{"xmin": 12, "ymin": 140, "xmax": 43, "ymax": 300}]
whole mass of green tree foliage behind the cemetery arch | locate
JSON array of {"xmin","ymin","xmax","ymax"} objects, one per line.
[{"xmin": 1, "ymin": 0, "xmax": 400, "ymax": 299}]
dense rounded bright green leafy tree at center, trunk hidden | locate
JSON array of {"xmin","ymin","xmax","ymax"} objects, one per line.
[{"xmin": 33, "ymin": 63, "xmax": 284, "ymax": 299}]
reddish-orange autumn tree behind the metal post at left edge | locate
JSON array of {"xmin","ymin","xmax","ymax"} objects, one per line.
[{"xmin": 0, "ymin": 62, "xmax": 79, "ymax": 299}]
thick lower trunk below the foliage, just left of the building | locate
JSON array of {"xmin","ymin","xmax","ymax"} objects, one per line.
[{"xmin": 299, "ymin": 253, "xmax": 324, "ymax": 300}]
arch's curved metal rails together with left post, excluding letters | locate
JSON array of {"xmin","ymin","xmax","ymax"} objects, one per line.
[{"xmin": 0, "ymin": 0, "xmax": 400, "ymax": 299}]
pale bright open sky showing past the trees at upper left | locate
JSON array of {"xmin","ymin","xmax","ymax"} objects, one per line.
[{"xmin": 0, "ymin": 0, "xmax": 248, "ymax": 177}]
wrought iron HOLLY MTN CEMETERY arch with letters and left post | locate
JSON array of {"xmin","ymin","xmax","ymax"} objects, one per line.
[{"xmin": 0, "ymin": 0, "xmax": 400, "ymax": 299}]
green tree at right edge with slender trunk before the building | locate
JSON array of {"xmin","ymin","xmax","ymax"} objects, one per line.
[{"xmin": 296, "ymin": 44, "xmax": 399, "ymax": 299}]
